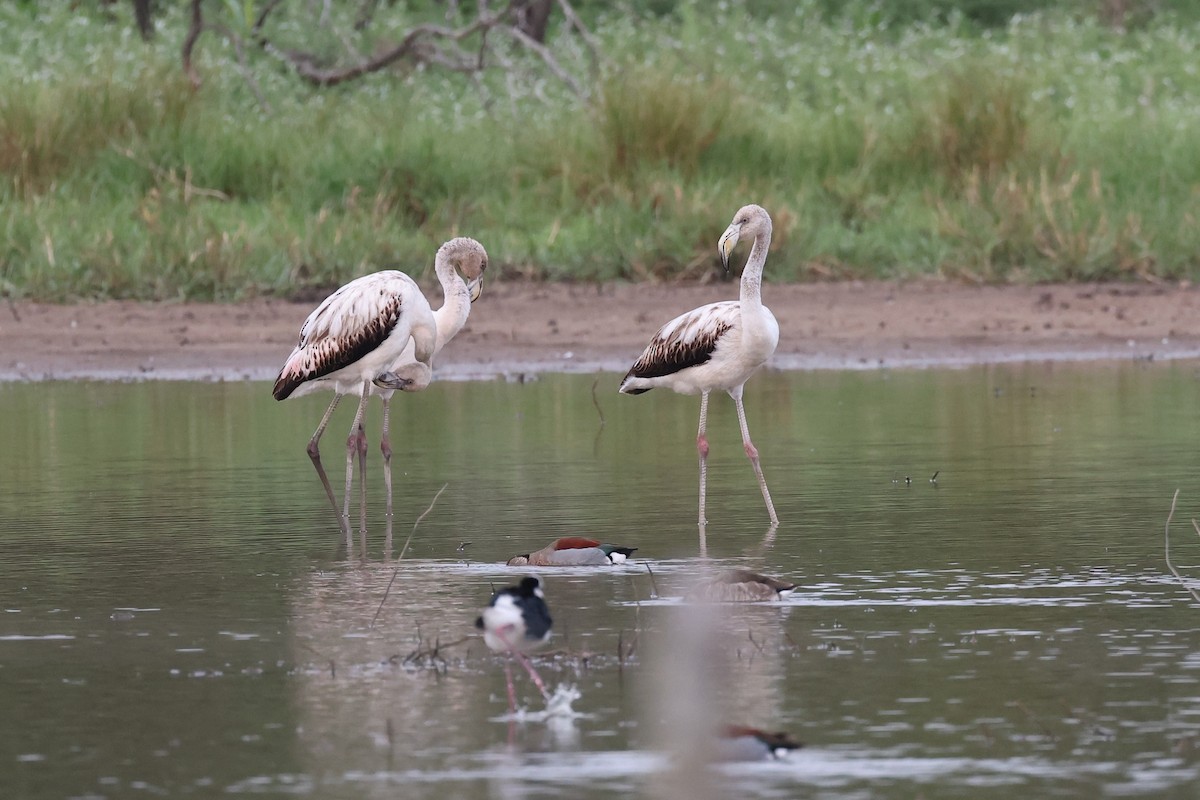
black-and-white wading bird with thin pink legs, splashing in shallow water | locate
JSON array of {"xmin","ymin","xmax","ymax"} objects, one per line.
[{"xmin": 475, "ymin": 577, "xmax": 553, "ymax": 711}]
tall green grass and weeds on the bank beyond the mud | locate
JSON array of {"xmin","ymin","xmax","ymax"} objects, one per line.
[{"xmin": 0, "ymin": 0, "xmax": 1200, "ymax": 300}]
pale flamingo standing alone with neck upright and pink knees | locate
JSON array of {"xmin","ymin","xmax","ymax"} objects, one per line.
[{"xmin": 620, "ymin": 205, "xmax": 779, "ymax": 525}]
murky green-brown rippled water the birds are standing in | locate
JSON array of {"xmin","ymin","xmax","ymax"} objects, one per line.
[{"xmin": 0, "ymin": 362, "xmax": 1200, "ymax": 798}]
